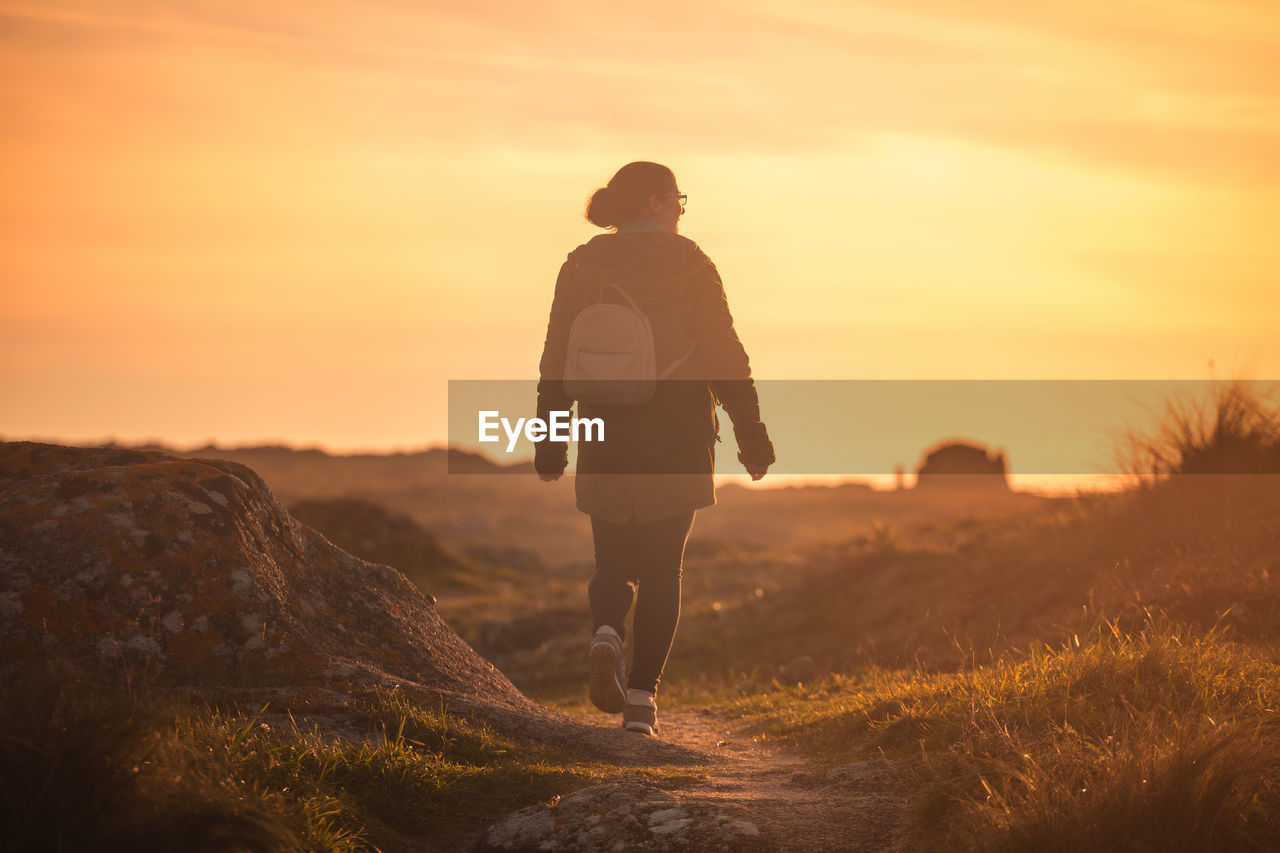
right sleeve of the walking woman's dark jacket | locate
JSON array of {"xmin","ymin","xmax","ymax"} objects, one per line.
[{"xmin": 692, "ymin": 261, "xmax": 774, "ymax": 466}]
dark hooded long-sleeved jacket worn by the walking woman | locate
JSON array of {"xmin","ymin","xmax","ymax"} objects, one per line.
[{"xmin": 535, "ymin": 231, "xmax": 773, "ymax": 523}]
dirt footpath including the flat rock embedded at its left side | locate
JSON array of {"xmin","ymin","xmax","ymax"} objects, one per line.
[{"xmin": 476, "ymin": 708, "xmax": 906, "ymax": 853}]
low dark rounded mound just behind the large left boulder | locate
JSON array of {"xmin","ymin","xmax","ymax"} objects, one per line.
[{"xmin": 289, "ymin": 497, "xmax": 466, "ymax": 593}]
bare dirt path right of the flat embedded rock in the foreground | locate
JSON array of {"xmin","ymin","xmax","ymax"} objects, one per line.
[{"xmin": 645, "ymin": 708, "xmax": 906, "ymax": 853}]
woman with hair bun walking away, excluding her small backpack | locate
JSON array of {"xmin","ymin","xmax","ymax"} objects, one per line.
[{"xmin": 534, "ymin": 161, "xmax": 774, "ymax": 734}]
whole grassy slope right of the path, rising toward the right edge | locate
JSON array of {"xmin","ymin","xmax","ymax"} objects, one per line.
[{"xmin": 691, "ymin": 476, "xmax": 1280, "ymax": 850}]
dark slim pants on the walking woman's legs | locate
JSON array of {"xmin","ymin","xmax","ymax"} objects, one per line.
[{"xmin": 588, "ymin": 511, "xmax": 694, "ymax": 693}]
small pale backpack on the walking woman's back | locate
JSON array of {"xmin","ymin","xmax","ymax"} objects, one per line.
[{"xmin": 564, "ymin": 284, "xmax": 694, "ymax": 406}]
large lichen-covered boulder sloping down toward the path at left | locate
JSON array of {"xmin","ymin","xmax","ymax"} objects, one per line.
[{"xmin": 0, "ymin": 442, "xmax": 536, "ymax": 712}]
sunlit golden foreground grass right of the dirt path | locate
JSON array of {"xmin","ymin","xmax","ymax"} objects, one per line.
[{"xmin": 724, "ymin": 617, "xmax": 1280, "ymax": 852}]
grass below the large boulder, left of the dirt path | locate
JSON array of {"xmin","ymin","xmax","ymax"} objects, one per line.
[{"xmin": 0, "ymin": 666, "xmax": 685, "ymax": 852}]
